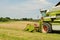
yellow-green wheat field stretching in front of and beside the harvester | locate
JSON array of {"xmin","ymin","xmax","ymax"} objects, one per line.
[{"xmin": 0, "ymin": 21, "xmax": 60, "ymax": 40}]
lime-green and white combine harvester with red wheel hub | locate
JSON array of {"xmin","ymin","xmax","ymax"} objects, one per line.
[{"xmin": 25, "ymin": 2, "xmax": 60, "ymax": 33}]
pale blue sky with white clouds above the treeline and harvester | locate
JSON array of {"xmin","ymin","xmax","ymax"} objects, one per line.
[{"xmin": 0, "ymin": 0, "xmax": 60, "ymax": 19}]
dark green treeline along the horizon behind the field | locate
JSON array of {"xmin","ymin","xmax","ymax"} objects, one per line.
[{"xmin": 0, "ymin": 17, "xmax": 38, "ymax": 22}]
